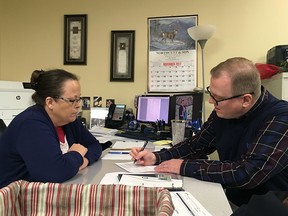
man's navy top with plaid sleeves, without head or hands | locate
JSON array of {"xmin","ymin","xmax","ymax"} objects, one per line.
[{"xmin": 155, "ymin": 88, "xmax": 288, "ymax": 205}]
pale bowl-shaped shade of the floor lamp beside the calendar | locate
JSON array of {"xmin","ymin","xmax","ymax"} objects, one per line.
[{"xmin": 187, "ymin": 25, "xmax": 216, "ymax": 41}]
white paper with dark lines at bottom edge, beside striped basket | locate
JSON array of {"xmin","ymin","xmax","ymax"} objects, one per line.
[{"xmin": 170, "ymin": 191, "xmax": 212, "ymax": 216}]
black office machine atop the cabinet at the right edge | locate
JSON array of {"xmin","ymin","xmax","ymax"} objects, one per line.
[{"xmin": 266, "ymin": 45, "xmax": 288, "ymax": 66}]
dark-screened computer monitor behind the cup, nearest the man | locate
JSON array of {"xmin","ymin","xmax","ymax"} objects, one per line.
[{"xmin": 170, "ymin": 92, "xmax": 203, "ymax": 128}]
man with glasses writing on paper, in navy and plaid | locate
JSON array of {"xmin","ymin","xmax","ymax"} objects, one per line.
[{"xmin": 130, "ymin": 57, "xmax": 288, "ymax": 206}]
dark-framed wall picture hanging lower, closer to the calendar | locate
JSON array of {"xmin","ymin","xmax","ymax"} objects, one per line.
[{"xmin": 110, "ymin": 30, "xmax": 135, "ymax": 82}]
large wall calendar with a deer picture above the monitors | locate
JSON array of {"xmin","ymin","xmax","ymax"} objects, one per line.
[{"xmin": 148, "ymin": 15, "xmax": 198, "ymax": 92}]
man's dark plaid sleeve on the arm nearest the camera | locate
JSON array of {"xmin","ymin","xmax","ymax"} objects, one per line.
[{"xmin": 180, "ymin": 115, "xmax": 288, "ymax": 190}]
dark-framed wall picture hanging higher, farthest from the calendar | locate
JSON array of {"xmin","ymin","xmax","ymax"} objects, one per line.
[{"xmin": 64, "ymin": 14, "xmax": 87, "ymax": 65}]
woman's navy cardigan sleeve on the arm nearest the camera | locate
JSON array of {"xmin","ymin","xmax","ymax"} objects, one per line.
[{"xmin": 16, "ymin": 119, "xmax": 83, "ymax": 182}]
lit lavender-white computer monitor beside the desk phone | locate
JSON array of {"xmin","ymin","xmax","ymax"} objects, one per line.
[{"xmin": 136, "ymin": 95, "xmax": 170, "ymax": 124}]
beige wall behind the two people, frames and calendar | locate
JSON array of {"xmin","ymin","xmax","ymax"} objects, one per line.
[{"xmin": 0, "ymin": 0, "xmax": 288, "ymax": 115}]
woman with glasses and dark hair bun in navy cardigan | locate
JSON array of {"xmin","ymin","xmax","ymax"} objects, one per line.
[{"xmin": 0, "ymin": 70, "xmax": 102, "ymax": 188}]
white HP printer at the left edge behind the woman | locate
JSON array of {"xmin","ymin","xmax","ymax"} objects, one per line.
[{"xmin": 0, "ymin": 81, "xmax": 34, "ymax": 126}]
